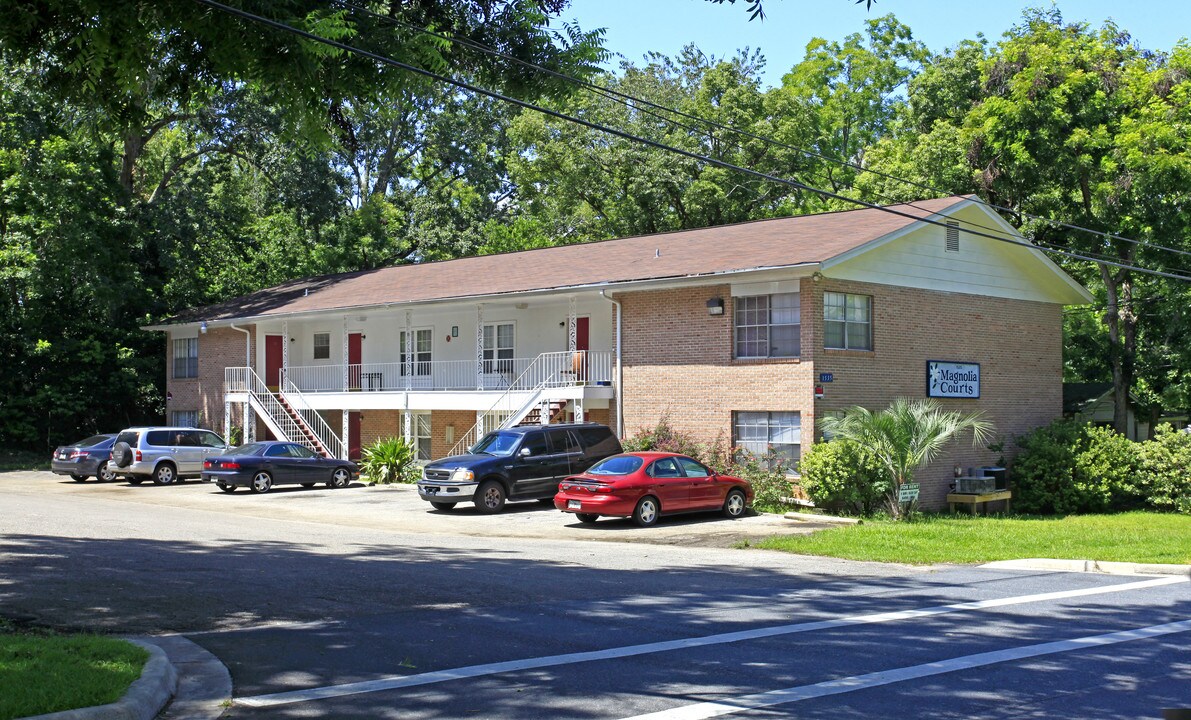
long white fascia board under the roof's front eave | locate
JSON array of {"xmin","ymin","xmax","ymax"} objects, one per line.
[{"xmin": 141, "ymin": 262, "xmax": 819, "ymax": 331}]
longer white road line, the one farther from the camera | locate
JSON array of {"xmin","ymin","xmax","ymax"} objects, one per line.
[{"xmin": 235, "ymin": 576, "xmax": 1191, "ymax": 707}]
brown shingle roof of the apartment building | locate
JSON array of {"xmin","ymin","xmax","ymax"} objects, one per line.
[{"xmin": 170, "ymin": 196, "xmax": 965, "ymax": 324}]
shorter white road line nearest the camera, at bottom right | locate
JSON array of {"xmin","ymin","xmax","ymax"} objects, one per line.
[{"xmin": 625, "ymin": 620, "xmax": 1191, "ymax": 720}]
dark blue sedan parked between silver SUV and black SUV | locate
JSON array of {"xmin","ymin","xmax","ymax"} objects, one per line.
[{"xmin": 202, "ymin": 440, "xmax": 360, "ymax": 493}]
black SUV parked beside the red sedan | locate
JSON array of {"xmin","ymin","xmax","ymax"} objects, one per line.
[{"xmin": 418, "ymin": 422, "xmax": 621, "ymax": 513}]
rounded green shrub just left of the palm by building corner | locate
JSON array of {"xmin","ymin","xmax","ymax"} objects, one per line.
[{"xmin": 798, "ymin": 439, "xmax": 890, "ymax": 515}]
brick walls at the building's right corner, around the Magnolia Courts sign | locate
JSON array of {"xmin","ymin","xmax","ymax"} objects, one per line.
[{"xmin": 610, "ymin": 278, "xmax": 1062, "ymax": 507}]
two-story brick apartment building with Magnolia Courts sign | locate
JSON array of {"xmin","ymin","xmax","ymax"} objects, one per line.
[{"xmin": 148, "ymin": 196, "xmax": 1091, "ymax": 505}]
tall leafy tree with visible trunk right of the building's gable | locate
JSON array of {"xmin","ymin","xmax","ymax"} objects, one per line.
[{"xmin": 860, "ymin": 10, "xmax": 1191, "ymax": 432}]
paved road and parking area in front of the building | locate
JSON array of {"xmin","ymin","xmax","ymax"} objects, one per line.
[{"xmin": 0, "ymin": 474, "xmax": 1191, "ymax": 720}]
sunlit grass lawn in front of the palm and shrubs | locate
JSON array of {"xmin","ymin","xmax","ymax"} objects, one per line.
[{"xmin": 749, "ymin": 513, "xmax": 1191, "ymax": 565}]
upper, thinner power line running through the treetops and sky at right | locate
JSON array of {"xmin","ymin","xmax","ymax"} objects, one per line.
[{"xmin": 332, "ymin": 0, "xmax": 1191, "ymax": 262}]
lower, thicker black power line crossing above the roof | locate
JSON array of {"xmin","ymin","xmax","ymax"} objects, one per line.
[{"xmin": 194, "ymin": 0, "xmax": 1191, "ymax": 282}]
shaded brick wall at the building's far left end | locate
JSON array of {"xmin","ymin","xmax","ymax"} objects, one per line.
[{"xmin": 162, "ymin": 325, "xmax": 256, "ymax": 434}]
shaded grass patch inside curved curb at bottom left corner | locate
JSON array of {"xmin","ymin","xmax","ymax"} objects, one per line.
[{"xmin": 0, "ymin": 620, "xmax": 149, "ymax": 720}]
